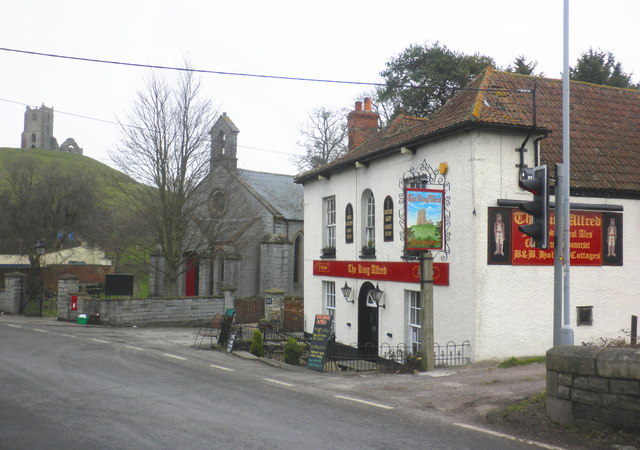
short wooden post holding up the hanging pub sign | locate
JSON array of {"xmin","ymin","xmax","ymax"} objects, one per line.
[{"xmin": 420, "ymin": 252, "xmax": 435, "ymax": 371}]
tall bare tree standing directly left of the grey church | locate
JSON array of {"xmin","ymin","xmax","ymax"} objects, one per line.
[{"xmin": 110, "ymin": 65, "xmax": 217, "ymax": 293}]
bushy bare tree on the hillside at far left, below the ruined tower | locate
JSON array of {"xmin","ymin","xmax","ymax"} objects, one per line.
[{"xmin": 0, "ymin": 153, "xmax": 100, "ymax": 266}]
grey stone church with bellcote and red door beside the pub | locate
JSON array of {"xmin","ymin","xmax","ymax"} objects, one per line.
[{"xmin": 157, "ymin": 113, "xmax": 303, "ymax": 298}]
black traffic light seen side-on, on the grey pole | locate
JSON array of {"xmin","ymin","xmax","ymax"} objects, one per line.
[{"xmin": 518, "ymin": 165, "xmax": 549, "ymax": 248}]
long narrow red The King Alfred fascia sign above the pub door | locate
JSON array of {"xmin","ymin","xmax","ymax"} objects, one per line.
[{"xmin": 313, "ymin": 259, "xmax": 449, "ymax": 286}]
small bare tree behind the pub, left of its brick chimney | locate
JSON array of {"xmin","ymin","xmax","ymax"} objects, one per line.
[{"xmin": 294, "ymin": 106, "xmax": 347, "ymax": 171}]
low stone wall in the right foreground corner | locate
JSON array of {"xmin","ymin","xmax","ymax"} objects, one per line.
[{"xmin": 547, "ymin": 346, "xmax": 640, "ymax": 431}]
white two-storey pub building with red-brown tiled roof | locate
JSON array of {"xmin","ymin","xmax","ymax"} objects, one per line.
[{"xmin": 296, "ymin": 69, "xmax": 640, "ymax": 361}]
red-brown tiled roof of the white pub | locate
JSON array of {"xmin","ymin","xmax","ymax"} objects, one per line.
[{"xmin": 297, "ymin": 69, "xmax": 640, "ymax": 195}]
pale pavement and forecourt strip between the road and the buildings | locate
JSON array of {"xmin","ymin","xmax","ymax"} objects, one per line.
[{"xmin": 5, "ymin": 314, "xmax": 640, "ymax": 450}]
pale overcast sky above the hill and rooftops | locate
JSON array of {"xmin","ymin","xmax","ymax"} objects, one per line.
[{"xmin": 0, "ymin": 0, "xmax": 640, "ymax": 174}]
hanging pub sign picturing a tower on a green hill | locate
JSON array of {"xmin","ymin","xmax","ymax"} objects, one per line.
[{"xmin": 404, "ymin": 188, "xmax": 444, "ymax": 251}]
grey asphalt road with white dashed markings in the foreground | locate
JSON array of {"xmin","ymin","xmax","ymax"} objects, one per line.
[{"xmin": 0, "ymin": 317, "xmax": 552, "ymax": 449}]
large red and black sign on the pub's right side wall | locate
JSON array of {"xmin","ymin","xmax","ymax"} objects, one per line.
[{"xmin": 487, "ymin": 208, "xmax": 622, "ymax": 266}]
